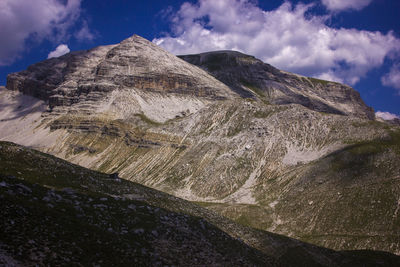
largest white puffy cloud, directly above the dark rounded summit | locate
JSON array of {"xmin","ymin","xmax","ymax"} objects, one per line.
[{"xmin": 153, "ymin": 0, "xmax": 400, "ymax": 85}]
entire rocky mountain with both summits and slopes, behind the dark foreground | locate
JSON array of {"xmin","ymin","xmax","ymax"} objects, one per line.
[{"xmin": 0, "ymin": 36, "xmax": 400, "ymax": 254}]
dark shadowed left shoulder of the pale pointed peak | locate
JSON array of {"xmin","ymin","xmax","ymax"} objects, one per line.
[{"xmin": 6, "ymin": 46, "xmax": 113, "ymax": 108}]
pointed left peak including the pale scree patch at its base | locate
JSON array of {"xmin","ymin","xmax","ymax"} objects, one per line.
[{"xmin": 7, "ymin": 35, "xmax": 235, "ymax": 121}]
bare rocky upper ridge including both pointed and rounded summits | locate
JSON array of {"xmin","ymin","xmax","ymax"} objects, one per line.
[{"xmin": 6, "ymin": 35, "xmax": 374, "ymax": 119}]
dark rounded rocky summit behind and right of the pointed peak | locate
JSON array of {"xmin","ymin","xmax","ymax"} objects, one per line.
[{"xmin": 180, "ymin": 51, "xmax": 375, "ymax": 120}]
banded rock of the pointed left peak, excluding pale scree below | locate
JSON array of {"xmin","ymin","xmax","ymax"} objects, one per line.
[{"xmin": 6, "ymin": 35, "xmax": 235, "ymax": 112}]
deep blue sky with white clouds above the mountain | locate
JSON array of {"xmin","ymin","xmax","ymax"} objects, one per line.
[{"xmin": 0, "ymin": 0, "xmax": 400, "ymax": 119}]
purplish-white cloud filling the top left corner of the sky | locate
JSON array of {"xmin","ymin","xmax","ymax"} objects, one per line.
[{"xmin": 0, "ymin": 0, "xmax": 81, "ymax": 66}]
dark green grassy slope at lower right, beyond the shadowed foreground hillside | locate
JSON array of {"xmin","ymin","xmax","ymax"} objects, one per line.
[{"xmin": 200, "ymin": 129, "xmax": 400, "ymax": 252}]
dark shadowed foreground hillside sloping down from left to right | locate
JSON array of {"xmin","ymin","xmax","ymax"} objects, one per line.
[{"xmin": 0, "ymin": 142, "xmax": 400, "ymax": 266}]
